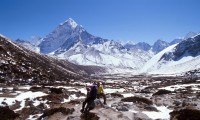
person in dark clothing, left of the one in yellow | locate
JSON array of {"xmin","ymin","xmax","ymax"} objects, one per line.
[{"xmin": 81, "ymin": 83, "xmax": 97, "ymax": 113}]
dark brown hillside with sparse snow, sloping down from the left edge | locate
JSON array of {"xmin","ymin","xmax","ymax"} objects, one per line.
[{"xmin": 0, "ymin": 35, "xmax": 103, "ymax": 84}]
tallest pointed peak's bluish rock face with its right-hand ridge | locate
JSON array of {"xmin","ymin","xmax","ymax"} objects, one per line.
[{"xmin": 40, "ymin": 18, "xmax": 107, "ymax": 54}]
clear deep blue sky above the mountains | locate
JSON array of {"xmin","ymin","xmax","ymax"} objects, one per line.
[{"xmin": 0, "ymin": 0, "xmax": 200, "ymax": 44}]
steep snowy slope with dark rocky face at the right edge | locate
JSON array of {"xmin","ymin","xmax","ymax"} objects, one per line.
[{"xmin": 141, "ymin": 34, "xmax": 200, "ymax": 74}]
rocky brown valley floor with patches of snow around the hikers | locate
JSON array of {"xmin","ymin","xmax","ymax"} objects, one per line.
[{"xmin": 0, "ymin": 74, "xmax": 200, "ymax": 120}]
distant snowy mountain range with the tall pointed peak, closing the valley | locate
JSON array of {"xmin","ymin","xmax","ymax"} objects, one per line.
[{"xmin": 16, "ymin": 18, "xmax": 198, "ymax": 72}]
